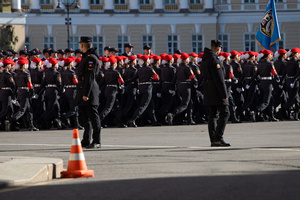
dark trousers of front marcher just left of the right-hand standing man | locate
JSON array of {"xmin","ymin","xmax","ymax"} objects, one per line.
[{"xmin": 172, "ymin": 83, "xmax": 192, "ymax": 115}]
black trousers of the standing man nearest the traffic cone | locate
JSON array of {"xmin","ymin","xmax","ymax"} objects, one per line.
[{"xmin": 79, "ymin": 105, "xmax": 101, "ymax": 145}]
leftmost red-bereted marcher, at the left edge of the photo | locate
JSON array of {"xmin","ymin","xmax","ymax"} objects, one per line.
[{"xmin": 0, "ymin": 59, "xmax": 15, "ymax": 128}]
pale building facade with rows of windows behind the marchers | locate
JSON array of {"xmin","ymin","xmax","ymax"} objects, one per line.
[{"xmin": 0, "ymin": 0, "xmax": 300, "ymax": 54}]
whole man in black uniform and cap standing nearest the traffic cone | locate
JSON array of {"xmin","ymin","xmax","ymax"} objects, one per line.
[{"xmin": 75, "ymin": 37, "xmax": 101, "ymax": 148}]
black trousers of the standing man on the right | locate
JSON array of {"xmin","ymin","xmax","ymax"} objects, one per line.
[{"xmin": 208, "ymin": 105, "xmax": 230, "ymax": 142}]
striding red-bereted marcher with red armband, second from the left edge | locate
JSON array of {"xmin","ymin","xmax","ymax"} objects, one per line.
[{"xmin": 5, "ymin": 57, "xmax": 39, "ymax": 131}]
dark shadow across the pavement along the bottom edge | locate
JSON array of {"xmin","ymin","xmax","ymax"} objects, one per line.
[{"xmin": 0, "ymin": 171, "xmax": 300, "ymax": 200}]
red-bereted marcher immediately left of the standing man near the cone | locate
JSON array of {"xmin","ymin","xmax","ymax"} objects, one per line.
[{"xmin": 60, "ymin": 57, "xmax": 83, "ymax": 129}]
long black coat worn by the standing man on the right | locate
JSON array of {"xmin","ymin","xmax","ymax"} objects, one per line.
[{"xmin": 201, "ymin": 48, "xmax": 228, "ymax": 105}]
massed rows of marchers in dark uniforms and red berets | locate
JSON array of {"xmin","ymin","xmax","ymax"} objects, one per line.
[{"xmin": 0, "ymin": 44, "xmax": 300, "ymax": 131}]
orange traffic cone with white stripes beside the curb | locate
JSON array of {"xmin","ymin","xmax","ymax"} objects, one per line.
[{"xmin": 60, "ymin": 129, "xmax": 94, "ymax": 178}]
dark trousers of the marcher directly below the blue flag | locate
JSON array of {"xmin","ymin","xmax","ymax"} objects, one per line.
[{"xmin": 256, "ymin": 80, "xmax": 272, "ymax": 112}]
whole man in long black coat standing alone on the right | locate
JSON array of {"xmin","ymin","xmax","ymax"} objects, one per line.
[{"xmin": 201, "ymin": 40, "xmax": 230, "ymax": 147}]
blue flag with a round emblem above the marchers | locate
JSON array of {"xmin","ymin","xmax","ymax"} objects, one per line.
[{"xmin": 255, "ymin": 0, "xmax": 281, "ymax": 52}]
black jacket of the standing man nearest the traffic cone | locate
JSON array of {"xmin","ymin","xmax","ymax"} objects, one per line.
[{"xmin": 75, "ymin": 48, "xmax": 100, "ymax": 106}]
